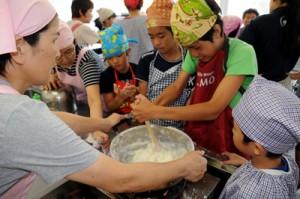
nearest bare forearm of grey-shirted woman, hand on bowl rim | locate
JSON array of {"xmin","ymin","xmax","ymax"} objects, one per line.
[{"xmin": 66, "ymin": 151, "xmax": 207, "ymax": 193}]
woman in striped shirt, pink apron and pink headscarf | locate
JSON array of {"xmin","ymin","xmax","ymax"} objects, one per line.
[{"xmin": 44, "ymin": 20, "xmax": 109, "ymax": 148}]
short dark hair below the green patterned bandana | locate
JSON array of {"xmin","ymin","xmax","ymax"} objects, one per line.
[{"xmin": 199, "ymin": 0, "xmax": 223, "ymax": 42}]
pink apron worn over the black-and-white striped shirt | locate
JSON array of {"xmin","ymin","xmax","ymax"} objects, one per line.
[{"xmin": 56, "ymin": 47, "xmax": 89, "ymax": 104}]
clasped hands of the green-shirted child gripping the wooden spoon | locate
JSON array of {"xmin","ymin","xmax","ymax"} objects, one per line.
[{"xmin": 130, "ymin": 94, "xmax": 155, "ymax": 122}]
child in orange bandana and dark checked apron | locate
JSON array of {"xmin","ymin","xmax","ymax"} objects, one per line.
[{"xmin": 136, "ymin": 0, "xmax": 195, "ymax": 129}]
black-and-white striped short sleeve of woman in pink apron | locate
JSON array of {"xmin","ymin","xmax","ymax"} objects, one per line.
[{"xmin": 78, "ymin": 50, "xmax": 101, "ymax": 87}]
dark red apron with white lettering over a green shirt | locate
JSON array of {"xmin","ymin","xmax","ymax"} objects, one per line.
[{"xmin": 185, "ymin": 51, "xmax": 240, "ymax": 154}]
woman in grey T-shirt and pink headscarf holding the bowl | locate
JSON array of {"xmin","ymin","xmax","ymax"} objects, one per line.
[{"xmin": 0, "ymin": 0, "xmax": 206, "ymax": 199}]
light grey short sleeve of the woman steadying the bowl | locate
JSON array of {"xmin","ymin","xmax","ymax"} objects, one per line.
[{"xmin": 5, "ymin": 100, "xmax": 99, "ymax": 183}]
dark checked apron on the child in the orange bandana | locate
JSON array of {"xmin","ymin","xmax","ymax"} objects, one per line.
[{"xmin": 147, "ymin": 46, "xmax": 191, "ymax": 129}]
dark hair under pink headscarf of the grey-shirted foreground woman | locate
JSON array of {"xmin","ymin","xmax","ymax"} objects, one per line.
[{"xmin": 0, "ymin": 15, "xmax": 57, "ymax": 77}]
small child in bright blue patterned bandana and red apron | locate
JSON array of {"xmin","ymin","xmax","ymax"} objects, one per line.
[{"xmin": 100, "ymin": 24, "xmax": 138, "ymax": 113}]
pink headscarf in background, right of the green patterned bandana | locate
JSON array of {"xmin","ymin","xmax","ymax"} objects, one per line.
[{"xmin": 222, "ymin": 15, "xmax": 243, "ymax": 37}]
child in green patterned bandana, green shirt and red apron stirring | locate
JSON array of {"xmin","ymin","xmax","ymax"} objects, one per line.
[{"xmin": 132, "ymin": 0, "xmax": 257, "ymax": 153}]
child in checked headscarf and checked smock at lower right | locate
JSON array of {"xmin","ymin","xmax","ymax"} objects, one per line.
[{"xmin": 220, "ymin": 76, "xmax": 300, "ymax": 199}]
